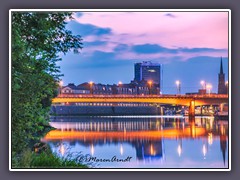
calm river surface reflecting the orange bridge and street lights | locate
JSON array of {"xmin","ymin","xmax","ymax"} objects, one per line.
[{"xmin": 42, "ymin": 116, "xmax": 228, "ymax": 168}]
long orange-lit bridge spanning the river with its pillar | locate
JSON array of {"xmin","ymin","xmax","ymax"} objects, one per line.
[{"xmin": 52, "ymin": 94, "xmax": 229, "ymax": 116}]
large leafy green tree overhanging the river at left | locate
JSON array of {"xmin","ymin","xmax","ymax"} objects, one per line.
[{"xmin": 11, "ymin": 12, "xmax": 82, "ymax": 154}]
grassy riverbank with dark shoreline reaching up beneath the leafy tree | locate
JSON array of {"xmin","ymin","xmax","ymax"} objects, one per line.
[{"xmin": 11, "ymin": 124, "xmax": 88, "ymax": 169}]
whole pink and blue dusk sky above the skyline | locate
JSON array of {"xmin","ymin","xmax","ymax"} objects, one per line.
[{"xmin": 58, "ymin": 11, "xmax": 229, "ymax": 94}]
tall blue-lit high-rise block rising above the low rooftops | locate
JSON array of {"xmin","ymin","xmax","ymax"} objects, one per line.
[{"xmin": 134, "ymin": 61, "xmax": 161, "ymax": 91}]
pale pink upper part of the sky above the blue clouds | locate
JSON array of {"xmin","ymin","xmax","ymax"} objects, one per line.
[{"xmin": 75, "ymin": 12, "xmax": 228, "ymax": 49}]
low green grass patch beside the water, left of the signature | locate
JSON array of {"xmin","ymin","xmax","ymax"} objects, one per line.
[{"xmin": 12, "ymin": 150, "xmax": 87, "ymax": 169}]
